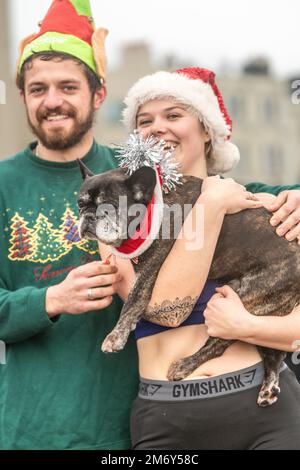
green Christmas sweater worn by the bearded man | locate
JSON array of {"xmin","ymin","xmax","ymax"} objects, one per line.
[{"xmin": 0, "ymin": 142, "xmax": 138, "ymax": 449}]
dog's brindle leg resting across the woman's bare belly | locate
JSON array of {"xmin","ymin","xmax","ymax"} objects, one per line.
[{"xmin": 167, "ymin": 337, "xmax": 234, "ymax": 380}]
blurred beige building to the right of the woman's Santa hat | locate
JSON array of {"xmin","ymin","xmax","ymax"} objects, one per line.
[{"xmin": 219, "ymin": 60, "xmax": 300, "ymax": 184}]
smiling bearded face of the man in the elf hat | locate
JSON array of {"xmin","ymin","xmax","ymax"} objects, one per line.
[{"xmin": 24, "ymin": 59, "xmax": 106, "ymax": 150}]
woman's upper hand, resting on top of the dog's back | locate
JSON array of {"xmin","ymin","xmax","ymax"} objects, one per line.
[{"xmin": 199, "ymin": 176, "xmax": 262, "ymax": 214}]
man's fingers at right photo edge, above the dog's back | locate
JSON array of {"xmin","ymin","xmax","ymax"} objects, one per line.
[{"xmin": 267, "ymin": 189, "xmax": 300, "ymax": 244}]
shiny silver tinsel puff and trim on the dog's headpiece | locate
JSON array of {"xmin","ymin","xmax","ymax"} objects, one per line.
[{"xmin": 116, "ymin": 130, "xmax": 182, "ymax": 193}]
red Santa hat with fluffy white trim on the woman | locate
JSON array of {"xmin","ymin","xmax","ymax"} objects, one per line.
[{"xmin": 123, "ymin": 67, "xmax": 240, "ymax": 174}]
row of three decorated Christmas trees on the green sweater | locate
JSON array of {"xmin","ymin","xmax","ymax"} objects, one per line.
[{"xmin": 8, "ymin": 207, "xmax": 98, "ymax": 264}]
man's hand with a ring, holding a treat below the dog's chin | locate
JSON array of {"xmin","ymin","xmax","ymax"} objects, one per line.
[{"xmin": 46, "ymin": 261, "xmax": 122, "ymax": 318}]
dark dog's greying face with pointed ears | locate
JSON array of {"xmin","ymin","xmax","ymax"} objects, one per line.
[{"xmin": 77, "ymin": 160, "xmax": 156, "ymax": 247}]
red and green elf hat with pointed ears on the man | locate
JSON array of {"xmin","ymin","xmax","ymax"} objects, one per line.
[{"xmin": 18, "ymin": 0, "xmax": 108, "ymax": 80}]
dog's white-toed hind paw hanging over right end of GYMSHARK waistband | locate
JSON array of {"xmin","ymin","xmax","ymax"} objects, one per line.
[{"xmin": 257, "ymin": 346, "xmax": 286, "ymax": 406}]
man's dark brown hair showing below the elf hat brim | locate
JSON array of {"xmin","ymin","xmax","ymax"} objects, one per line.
[{"xmin": 17, "ymin": 51, "xmax": 102, "ymax": 96}]
